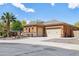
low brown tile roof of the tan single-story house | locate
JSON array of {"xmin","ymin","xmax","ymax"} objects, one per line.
[{"xmin": 26, "ymin": 20, "xmax": 79, "ymax": 29}]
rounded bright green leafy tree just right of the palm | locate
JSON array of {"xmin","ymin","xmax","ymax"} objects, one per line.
[{"xmin": 11, "ymin": 20, "xmax": 22, "ymax": 31}]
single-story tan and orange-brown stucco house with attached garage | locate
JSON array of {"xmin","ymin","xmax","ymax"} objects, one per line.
[{"xmin": 22, "ymin": 20, "xmax": 79, "ymax": 38}]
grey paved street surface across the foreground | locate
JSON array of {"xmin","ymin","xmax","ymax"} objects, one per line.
[{"xmin": 0, "ymin": 43, "xmax": 79, "ymax": 56}]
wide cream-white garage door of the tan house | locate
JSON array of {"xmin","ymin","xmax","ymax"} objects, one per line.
[{"xmin": 46, "ymin": 29, "xmax": 61, "ymax": 38}]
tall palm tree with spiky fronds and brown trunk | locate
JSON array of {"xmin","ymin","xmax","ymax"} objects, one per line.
[{"xmin": 1, "ymin": 12, "xmax": 16, "ymax": 37}]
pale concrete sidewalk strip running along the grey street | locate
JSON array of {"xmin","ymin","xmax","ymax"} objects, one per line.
[{"xmin": 0, "ymin": 38, "xmax": 79, "ymax": 50}]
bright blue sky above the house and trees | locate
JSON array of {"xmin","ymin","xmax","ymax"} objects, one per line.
[{"xmin": 0, "ymin": 3, "xmax": 79, "ymax": 24}]
